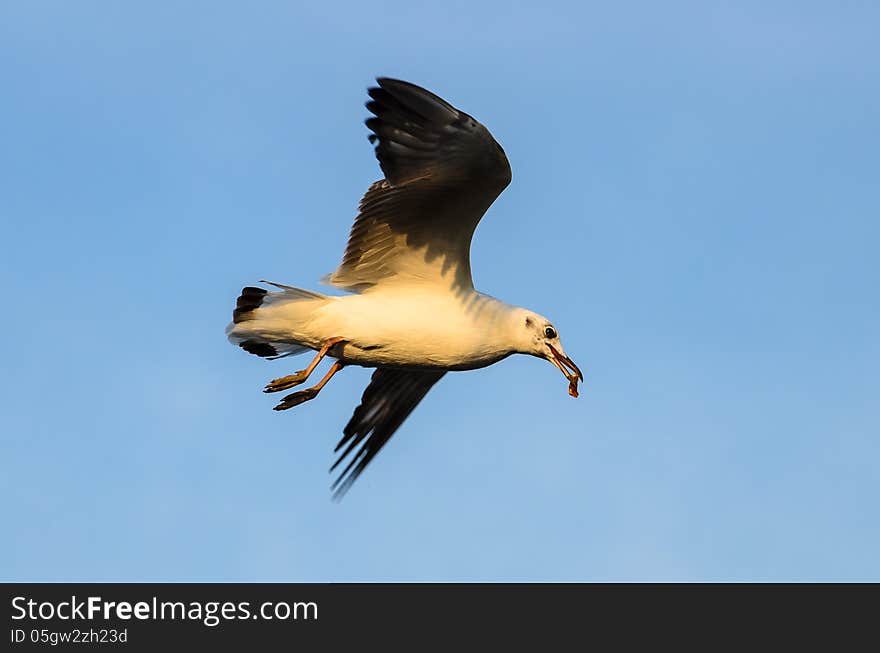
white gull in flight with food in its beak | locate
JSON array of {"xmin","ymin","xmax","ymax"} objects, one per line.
[{"xmin": 226, "ymin": 77, "xmax": 584, "ymax": 500}]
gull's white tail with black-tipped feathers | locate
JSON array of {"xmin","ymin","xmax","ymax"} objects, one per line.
[{"xmin": 226, "ymin": 281, "xmax": 329, "ymax": 358}]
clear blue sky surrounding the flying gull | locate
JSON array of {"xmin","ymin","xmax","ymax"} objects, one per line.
[{"xmin": 0, "ymin": 1, "xmax": 880, "ymax": 581}]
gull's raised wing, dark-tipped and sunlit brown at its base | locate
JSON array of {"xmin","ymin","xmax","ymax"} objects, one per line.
[{"xmin": 327, "ymin": 78, "xmax": 510, "ymax": 291}]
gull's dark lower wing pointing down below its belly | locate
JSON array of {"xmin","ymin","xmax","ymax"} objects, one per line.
[{"xmin": 330, "ymin": 367, "xmax": 446, "ymax": 499}]
